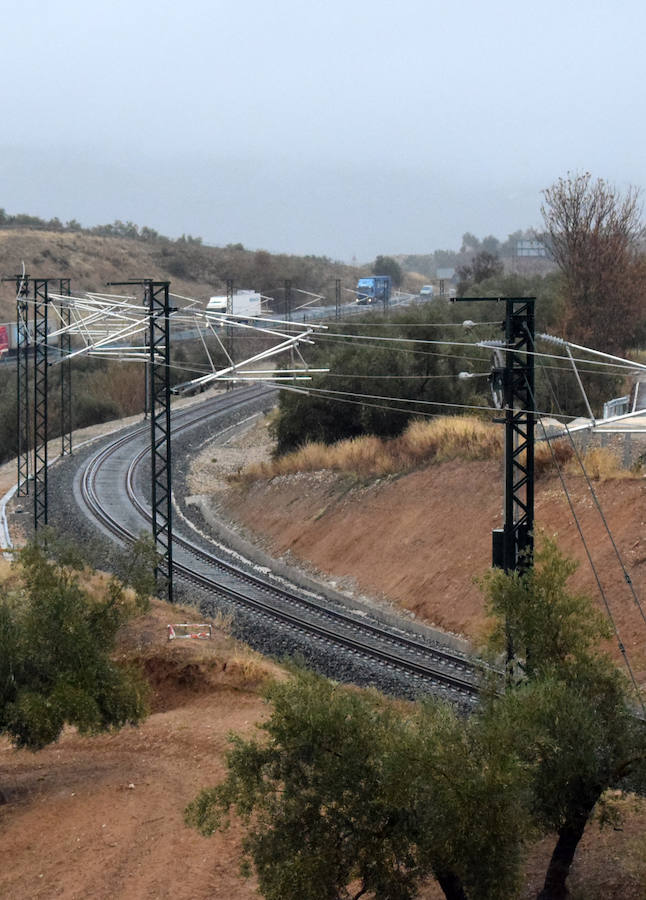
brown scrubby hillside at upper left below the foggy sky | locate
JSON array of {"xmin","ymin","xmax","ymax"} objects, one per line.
[{"xmin": 0, "ymin": 225, "xmax": 363, "ymax": 321}]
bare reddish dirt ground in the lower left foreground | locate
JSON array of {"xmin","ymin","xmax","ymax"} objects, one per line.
[{"xmin": 0, "ymin": 603, "xmax": 275, "ymax": 900}]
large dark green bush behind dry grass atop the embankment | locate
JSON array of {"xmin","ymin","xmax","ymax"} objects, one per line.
[{"xmin": 274, "ymin": 301, "xmax": 492, "ymax": 455}]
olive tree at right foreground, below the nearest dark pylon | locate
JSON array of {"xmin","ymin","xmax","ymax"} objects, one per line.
[{"xmin": 485, "ymin": 540, "xmax": 646, "ymax": 900}]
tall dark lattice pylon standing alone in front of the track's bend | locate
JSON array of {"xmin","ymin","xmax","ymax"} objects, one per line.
[{"xmin": 144, "ymin": 280, "xmax": 173, "ymax": 602}]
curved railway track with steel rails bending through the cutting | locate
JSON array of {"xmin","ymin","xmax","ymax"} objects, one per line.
[{"xmin": 80, "ymin": 388, "xmax": 486, "ymax": 704}]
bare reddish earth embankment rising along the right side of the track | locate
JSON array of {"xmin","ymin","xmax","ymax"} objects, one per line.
[{"xmin": 193, "ymin": 422, "xmax": 646, "ymax": 681}]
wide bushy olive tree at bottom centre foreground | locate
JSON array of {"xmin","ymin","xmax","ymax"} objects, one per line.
[{"xmin": 186, "ymin": 672, "xmax": 528, "ymax": 900}]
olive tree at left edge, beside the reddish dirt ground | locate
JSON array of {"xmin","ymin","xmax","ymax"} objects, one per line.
[{"xmin": 0, "ymin": 544, "xmax": 147, "ymax": 750}]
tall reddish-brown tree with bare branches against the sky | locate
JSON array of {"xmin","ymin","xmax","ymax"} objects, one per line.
[{"xmin": 541, "ymin": 172, "xmax": 646, "ymax": 353}]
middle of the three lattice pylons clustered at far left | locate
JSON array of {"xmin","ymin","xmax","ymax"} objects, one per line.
[{"xmin": 33, "ymin": 278, "xmax": 49, "ymax": 531}]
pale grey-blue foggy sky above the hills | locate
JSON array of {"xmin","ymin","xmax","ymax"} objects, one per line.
[{"xmin": 0, "ymin": 0, "xmax": 646, "ymax": 261}]
